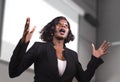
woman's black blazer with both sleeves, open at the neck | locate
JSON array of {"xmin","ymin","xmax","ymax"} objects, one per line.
[{"xmin": 9, "ymin": 40, "xmax": 103, "ymax": 82}]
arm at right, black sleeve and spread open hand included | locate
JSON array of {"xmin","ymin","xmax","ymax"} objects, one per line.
[{"xmin": 76, "ymin": 41, "xmax": 110, "ymax": 82}]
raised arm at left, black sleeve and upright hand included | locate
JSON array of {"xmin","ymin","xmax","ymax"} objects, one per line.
[{"xmin": 9, "ymin": 18, "xmax": 35, "ymax": 78}]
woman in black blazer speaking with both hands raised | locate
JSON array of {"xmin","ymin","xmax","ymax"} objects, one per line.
[{"xmin": 9, "ymin": 16, "xmax": 110, "ymax": 82}]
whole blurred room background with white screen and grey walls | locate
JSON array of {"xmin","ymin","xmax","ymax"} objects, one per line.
[{"xmin": 0, "ymin": 0, "xmax": 120, "ymax": 82}]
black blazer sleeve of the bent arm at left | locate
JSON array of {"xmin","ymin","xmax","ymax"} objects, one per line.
[{"xmin": 9, "ymin": 40, "xmax": 35, "ymax": 78}]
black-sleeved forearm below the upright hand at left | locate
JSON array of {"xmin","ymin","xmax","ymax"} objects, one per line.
[{"xmin": 9, "ymin": 40, "xmax": 29, "ymax": 78}]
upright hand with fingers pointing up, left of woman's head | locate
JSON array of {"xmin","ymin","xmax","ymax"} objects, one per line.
[{"xmin": 22, "ymin": 17, "xmax": 35, "ymax": 43}]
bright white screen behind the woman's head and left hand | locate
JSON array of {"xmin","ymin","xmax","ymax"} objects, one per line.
[{"xmin": 1, "ymin": 0, "xmax": 78, "ymax": 61}]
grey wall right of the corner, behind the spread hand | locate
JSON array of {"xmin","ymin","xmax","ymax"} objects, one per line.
[{"xmin": 96, "ymin": 0, "xmax": 120, "ymax": 82}]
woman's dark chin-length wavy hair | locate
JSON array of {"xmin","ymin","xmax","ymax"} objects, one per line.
[{"xmin": 40, "ymin": 16, "xmax": 74, "ymax": 43}]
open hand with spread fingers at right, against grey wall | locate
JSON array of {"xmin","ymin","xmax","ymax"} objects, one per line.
[{"xmin": 92, "ymin": 41, "xmax": 110, "ymax": 58}]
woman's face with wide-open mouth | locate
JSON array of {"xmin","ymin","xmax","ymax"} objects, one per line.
[{"xmin": 54, "ymin": 19, "xmax": 69, "ymax": 40}]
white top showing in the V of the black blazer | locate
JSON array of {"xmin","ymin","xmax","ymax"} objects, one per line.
[{"xmin": 57, "ymin": 59, "xmax": 67, "ymax": 76}]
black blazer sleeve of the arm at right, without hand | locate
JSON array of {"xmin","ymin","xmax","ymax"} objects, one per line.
[{"xmin": 75, "ymin": 55, "xmax": 103, "ymax": 82}]
